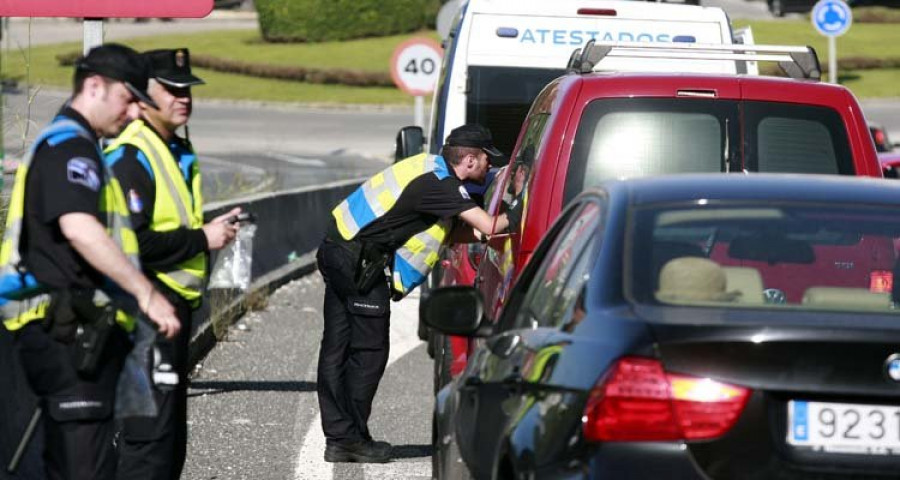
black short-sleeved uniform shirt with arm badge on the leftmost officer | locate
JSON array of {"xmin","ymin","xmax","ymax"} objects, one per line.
[{"xmin": 20, "ymin": 107, "xmax": 106, "ymax": 288}]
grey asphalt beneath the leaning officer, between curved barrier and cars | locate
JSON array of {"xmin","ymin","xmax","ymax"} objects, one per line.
[{"xmin": 182, "ymin": 274, "xmax": 432, "ymax": 480}]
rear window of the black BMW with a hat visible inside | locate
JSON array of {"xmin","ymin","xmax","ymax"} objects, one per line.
[{"xmin": 627, "ymin": 203, "xmax": 900, "ymax": 313}]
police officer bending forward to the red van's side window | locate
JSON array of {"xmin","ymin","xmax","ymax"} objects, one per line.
[{"xmin": 317, "ymin": 125, "xmax": 508, "ymax": 462}]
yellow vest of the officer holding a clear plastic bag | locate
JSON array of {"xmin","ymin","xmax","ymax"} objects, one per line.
[{"xmin": 106, "ymin": 120, "xmax": 206, "ymax": 306}]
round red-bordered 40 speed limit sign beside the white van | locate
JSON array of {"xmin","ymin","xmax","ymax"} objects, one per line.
[{"xmin": 391, "ymin": 38, "xmax": 441, "ymax": 96}]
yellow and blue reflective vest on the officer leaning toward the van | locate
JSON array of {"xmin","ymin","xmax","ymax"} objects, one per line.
[{"xmin": 331, "ymin": 153, "xmax": 451, "ymax": 296}]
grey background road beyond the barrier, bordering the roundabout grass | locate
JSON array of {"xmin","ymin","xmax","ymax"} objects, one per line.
[{"xmin": 3, "ymin": 87, "xmax": 413, "ymax": 201}]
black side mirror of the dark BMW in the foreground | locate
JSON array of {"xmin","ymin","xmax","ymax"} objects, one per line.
[{"xmin": 419, "ymin": 285, "xmax": 484, "ymax": 337}]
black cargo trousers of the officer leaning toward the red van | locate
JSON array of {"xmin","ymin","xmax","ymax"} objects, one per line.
[{"xmin": 316, "ymin": 240, "xmax": 391, "ymax": 445}]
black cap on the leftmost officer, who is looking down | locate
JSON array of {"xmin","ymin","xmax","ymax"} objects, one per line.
[{"xmin": 75, "ymin": 43, "xmax": 157, "ymax": 108}]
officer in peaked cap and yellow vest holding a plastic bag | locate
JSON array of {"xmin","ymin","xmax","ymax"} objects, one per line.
[{"xmin": 106, "ymin": 48, "xmax": 241, "ymax": 480}]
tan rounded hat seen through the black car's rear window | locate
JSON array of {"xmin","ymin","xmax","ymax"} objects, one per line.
[{"xmin": 656, "ymin": 257, "xmax": 740, "ymax": 302}]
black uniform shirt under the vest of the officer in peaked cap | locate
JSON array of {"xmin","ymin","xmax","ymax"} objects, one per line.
[{"xmin": 106, "ymin": 124, "xmax": 208, "ymax": 269}]
